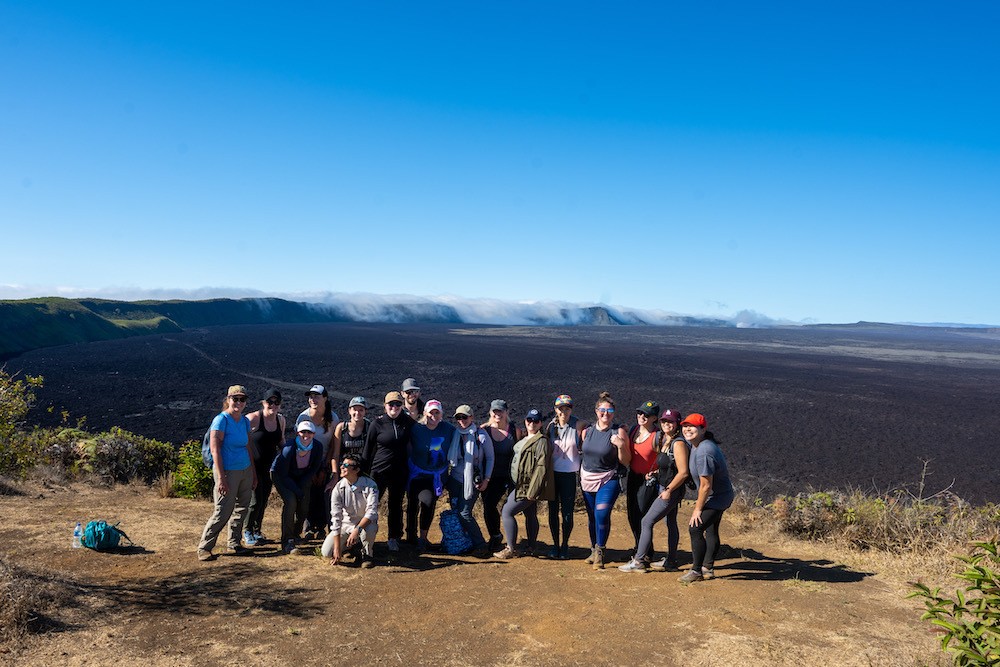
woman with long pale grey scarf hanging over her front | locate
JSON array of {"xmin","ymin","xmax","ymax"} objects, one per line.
[{"xmin": 446, "ymin": 405, "xmax": 494, "ymax": 555}]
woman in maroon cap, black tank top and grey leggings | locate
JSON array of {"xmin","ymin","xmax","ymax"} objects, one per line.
[{"xmin": 618, "ymin": 410, "xmax": 691, "ymax": 572}]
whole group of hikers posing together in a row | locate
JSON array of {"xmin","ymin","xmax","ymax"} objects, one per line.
[{"xmin": 198, "ymin": 378, "xmax": 734, "ymax": 582}]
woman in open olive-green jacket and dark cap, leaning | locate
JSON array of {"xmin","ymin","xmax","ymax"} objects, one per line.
[{"xmin": 493, "ymin": 410, "xmax": 556, "ymax": 559}]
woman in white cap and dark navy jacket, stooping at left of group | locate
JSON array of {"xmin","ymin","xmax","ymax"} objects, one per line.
[{"xmin": 271, "ymin": 420, "xmax": 323, "ymax": 554}]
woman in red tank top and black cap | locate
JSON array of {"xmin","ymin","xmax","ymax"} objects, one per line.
[{"xmin": 625, "ymin": 401, "xmax": 660, "ymax": 555}]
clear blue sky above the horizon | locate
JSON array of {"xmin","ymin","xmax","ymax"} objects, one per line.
[{"xmin": 0, "ymin": 1, "xmax": 1000, "ymax": 324}]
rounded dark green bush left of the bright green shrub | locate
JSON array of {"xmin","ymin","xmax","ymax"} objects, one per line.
[{"xmin": 86, "ymin": 426, "xmax": 177, "ymax": 484}]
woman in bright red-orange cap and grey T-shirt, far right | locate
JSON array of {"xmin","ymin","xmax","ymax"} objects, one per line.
[{"xmin": 680, "ymin": 413, "xmax": 735, "ymax": 583}]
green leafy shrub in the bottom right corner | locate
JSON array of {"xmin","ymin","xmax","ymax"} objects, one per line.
[{"xmin": 907, "ymin": 539, "xmax": 1000, "ymax": 666}]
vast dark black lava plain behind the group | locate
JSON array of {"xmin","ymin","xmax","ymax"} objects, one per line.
[{"xmin": 13, "ymin": 323, "xmax": 1000, "ymax": 502}]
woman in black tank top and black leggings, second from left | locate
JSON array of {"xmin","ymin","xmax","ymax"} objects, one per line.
[{"xmin": 243, "ymin": 389, "xmax": 285, "ymax": 547}]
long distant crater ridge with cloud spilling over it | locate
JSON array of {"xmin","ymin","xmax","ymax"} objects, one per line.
[{"xmin": 0, "ymin": 297, "xmax": 733, "ymax": 361}]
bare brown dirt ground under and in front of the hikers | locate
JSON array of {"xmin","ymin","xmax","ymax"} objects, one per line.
[{"xmin": 0, "ymin": 485, "xmax": 947, "ymax": 666}]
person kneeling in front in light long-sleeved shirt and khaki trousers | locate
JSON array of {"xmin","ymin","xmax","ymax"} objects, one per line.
[{"xmin": 322, "ymin": 453, "xmax": 378, "ymax": 568}]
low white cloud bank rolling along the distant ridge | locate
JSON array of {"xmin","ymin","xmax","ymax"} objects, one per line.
[{"xmin": 0, "ymin": 285, "xmax": 800, "ymax": 328}]
